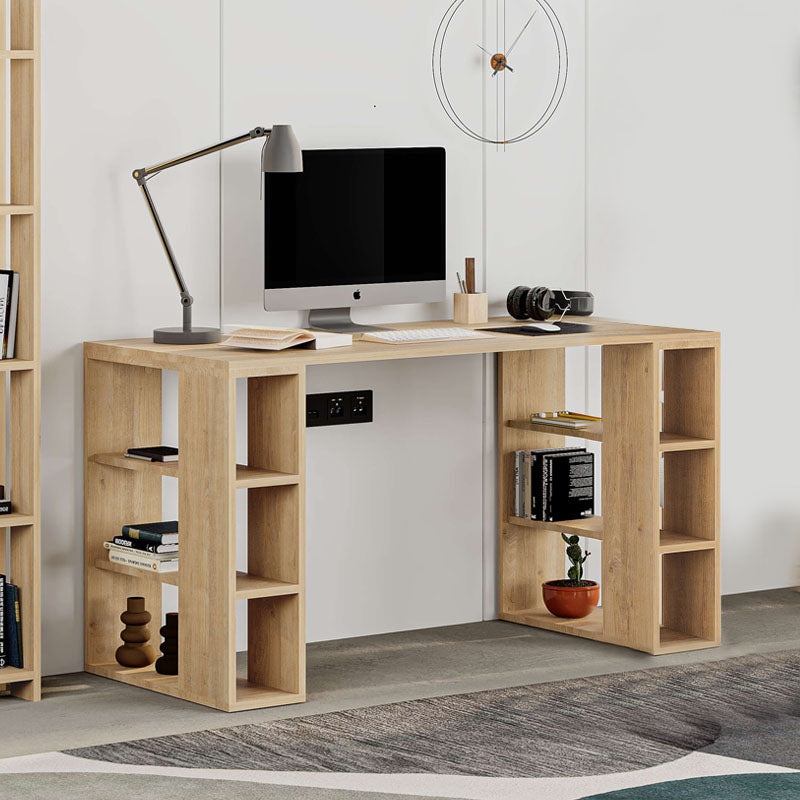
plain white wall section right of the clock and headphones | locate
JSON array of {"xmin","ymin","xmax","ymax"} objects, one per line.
[{"xmin": 587, "ymin": 0, "xmax": 800, "ymax": 593}]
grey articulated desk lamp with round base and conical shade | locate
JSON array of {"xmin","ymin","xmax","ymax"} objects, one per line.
[{"xmin": 133, "ymin": 125, "xmax": 303, "ymax": 344}]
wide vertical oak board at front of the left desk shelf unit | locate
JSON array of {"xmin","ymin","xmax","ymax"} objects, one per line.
[{"xmin": 178, "ymin": 371, "xmax": 236, "ymax": 710}]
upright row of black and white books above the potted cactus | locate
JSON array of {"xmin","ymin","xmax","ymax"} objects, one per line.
[{"xmin": 514, "ymin": 447, "xmax": 594, "ymax": 522}]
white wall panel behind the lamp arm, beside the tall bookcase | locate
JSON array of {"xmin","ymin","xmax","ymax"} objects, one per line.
[{"xmin": 42, "ymin": 0, "xmax": 219, "ymax": 674}]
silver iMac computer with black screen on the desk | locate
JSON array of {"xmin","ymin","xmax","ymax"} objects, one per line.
[{"xmin": 264, "ymin": 147, "xmax": 446, "ymax": 331}]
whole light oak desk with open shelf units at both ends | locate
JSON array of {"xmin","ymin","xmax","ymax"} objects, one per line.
[{"xmin": 84, "ymin": 318, "xmax": 720, "ymax": 711}]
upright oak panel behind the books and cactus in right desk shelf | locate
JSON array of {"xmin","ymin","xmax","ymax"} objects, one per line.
[{"xmin": 497, "ymin": 349, "xmax": 565, "ymax": 613}]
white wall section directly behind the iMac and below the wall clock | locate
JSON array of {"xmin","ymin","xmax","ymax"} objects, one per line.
[{"xmin": 222, "ymin": 0, "xmax": 584, "ymax": 646}]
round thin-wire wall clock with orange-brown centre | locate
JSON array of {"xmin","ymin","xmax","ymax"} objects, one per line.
[{"xmin": 432, "ymin": 0, "xmax": 569, "ymax": 145}]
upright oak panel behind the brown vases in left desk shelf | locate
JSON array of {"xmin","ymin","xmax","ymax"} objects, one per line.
[{"xmin": 84, "ymin": 358, "xmax": 161, "ymax": 674}]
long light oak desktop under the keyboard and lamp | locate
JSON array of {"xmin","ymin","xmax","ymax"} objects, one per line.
[{"xmin": 84, "ymin": 317, "xmax": 719, "ymax": 377}]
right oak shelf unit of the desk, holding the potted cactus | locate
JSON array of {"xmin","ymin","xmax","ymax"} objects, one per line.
[{"xmin": 498, "ymin": 342, "xmax": 721, "ymax": 655}]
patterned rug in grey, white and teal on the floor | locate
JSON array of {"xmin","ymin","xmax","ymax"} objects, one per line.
[{"xmin": 0, "ymin": 651, "xmax": 800, "ymax": 800}]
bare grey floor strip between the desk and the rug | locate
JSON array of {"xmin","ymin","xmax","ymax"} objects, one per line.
[{"xmin": 0, "ymin": 589, "xmax": 800, "ymax": 758}]
